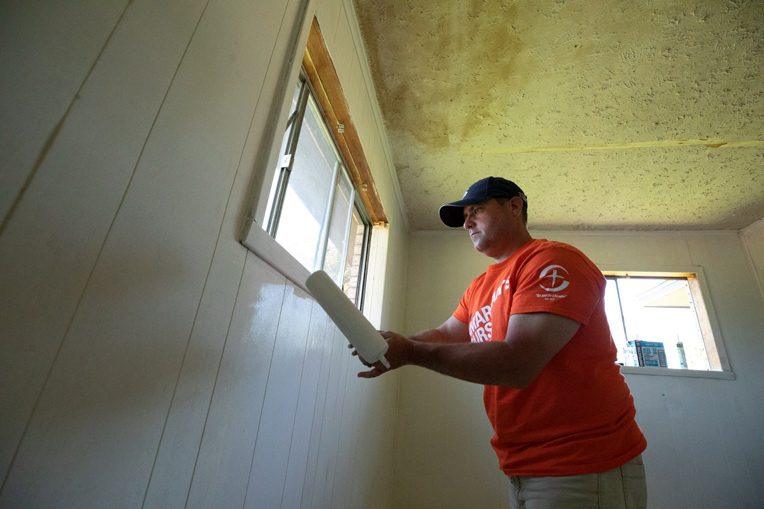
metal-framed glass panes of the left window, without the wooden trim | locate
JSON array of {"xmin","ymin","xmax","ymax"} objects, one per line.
[{"xmin": 266, "ymin": 76, "xmax": 371, "ymax": 305}]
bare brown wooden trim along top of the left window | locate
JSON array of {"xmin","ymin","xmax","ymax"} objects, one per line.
[{"xmin": 302, "ymin": 18, "xmax": 388, "ymax": 226}]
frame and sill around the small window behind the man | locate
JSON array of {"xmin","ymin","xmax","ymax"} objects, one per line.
[{"xmin": 600, "ymin": 265, "xmax": 735, "ymax": 380}]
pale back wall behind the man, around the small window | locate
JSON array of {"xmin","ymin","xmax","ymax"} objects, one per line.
[{"xmin": 395, "ymin": 232, "xmax": 764, "ymax": 509}]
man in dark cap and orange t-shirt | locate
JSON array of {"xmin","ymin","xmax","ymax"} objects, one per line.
[{"xmin": 359, "ymin": 177, "xmax": 646, "ymax": 509}]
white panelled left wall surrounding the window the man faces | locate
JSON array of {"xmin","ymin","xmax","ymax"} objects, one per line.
[{"xmin": 0, "ymin": 0, "xmax": 406, "ymax": 509}]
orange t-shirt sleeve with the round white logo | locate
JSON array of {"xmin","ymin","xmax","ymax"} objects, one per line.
[{"xmin": 510, "ymin": 247, "xmax": 605, "ymax": 325}]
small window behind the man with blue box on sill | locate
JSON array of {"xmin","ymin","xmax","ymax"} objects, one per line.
[{"xmin": 605, "ymin": 272, "xmax": 729, "ymax": 371}]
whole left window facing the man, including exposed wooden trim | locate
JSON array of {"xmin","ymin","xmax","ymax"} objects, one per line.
[{"xmin": 241, "ymin": 18, "xmax": 387, "ymax": 308}]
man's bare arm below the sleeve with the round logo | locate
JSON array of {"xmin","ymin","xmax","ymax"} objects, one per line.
[{"xmin": 358, "ymin": 313, "xmax": 580, "ymax": 388}]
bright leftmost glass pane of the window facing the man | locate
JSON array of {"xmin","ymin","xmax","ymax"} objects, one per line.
[{"xmin": 276, "ymin": 97, "xmax": 338, "ymax": 270}]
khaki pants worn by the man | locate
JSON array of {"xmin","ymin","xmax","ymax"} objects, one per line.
[{"xmin": 509, "ymin": 455, "xmax": 647, "ymax": 509}]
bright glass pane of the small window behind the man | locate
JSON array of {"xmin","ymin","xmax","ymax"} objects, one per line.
[{"xmin": 608, "ymin": 278, "xmax": 710, "ymax": 370}]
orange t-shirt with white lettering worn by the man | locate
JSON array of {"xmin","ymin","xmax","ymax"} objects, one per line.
[{"xmin": 453, "ymin": 240, "xmax": 647, "ymax": 476}]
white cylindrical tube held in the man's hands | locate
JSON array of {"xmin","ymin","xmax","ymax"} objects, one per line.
[{"xmin": 305, "ymin": 270, "xmax": 390, "ymax": 369}]
